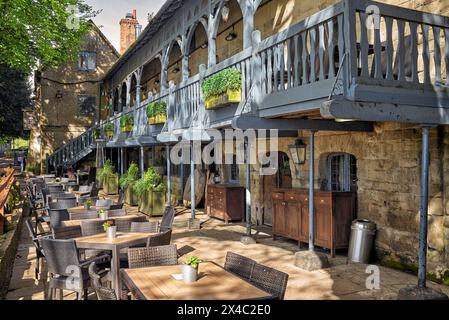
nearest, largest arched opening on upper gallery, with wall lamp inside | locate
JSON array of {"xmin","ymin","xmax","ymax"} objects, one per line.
[{"xmin": 216, "ymin": 0, "xmax": 243, "ymax": 63}]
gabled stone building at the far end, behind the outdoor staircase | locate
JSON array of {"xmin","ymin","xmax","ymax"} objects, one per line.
[{"xmin": 28, "ymin": 22, "xmax": 119, "ymax": 172}]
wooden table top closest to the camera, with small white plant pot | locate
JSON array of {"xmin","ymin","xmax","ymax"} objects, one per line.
[{"xmin": 121, "ymin": 262, "xmax": 272, "ymax": 300}]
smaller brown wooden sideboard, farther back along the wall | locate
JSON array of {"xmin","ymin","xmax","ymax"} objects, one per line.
[{"xmin": 206, "ymin": 184, "xmax": 245, "ymax": 223}]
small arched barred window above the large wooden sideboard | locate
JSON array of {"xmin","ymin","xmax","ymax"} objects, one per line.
[{"xmin": 327, "ymin": 153, "xmax": 357, "ymax": 191}]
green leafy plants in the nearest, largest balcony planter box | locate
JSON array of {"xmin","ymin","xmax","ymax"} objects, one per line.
[{"xmin": 201, "ymin": 68, "xmax": 242, "ymax": 99}]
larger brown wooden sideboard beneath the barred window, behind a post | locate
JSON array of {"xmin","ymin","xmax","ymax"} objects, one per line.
[{"xmin": 272, "ymin": 189, "xmax": 356, "ymax": 256}]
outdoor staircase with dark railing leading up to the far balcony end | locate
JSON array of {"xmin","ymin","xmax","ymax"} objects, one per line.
[{"xmin": 46, "ymin": 127, "xmax": 95, "ymax": 173}]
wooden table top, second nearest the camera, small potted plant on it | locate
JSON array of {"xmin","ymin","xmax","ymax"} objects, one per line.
[{"xmin": 73, "ymin": 232, "xmax": 155, "ymax": 250}]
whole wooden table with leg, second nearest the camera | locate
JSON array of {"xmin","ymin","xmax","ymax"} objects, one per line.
[{"xmin": 74, "ymin": 232, "xmax": 155, "ymax": 297}]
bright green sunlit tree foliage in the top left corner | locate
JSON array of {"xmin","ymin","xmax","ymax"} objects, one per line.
[{"xmin": 0, "ymin": 0, "xmax": 98, "ymax": 73}]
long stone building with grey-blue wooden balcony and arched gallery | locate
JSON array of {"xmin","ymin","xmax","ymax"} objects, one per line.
[{"xmin": 51, "ymin": 0, "xmax": 449, "ymax": 280}]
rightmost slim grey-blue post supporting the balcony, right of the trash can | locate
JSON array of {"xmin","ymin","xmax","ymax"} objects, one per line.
[{"xmin": 418, "ymin": 127, "xmax": 430, "ymax": 288}]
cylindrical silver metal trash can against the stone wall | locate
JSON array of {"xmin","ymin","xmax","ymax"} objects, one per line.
[{"xmin": 348, "ymin": 219, "xmax": 376, "ymax": 263}]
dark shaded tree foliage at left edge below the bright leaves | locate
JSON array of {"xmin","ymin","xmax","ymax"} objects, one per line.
[{"xmin": 0, "ymin": 64, "xmax": 31, "ymax": 138}]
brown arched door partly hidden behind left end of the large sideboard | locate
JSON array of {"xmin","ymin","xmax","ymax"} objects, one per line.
[{"xmin": 262, "ymin": 151, "xmax": 292, "ymax": 226}]
